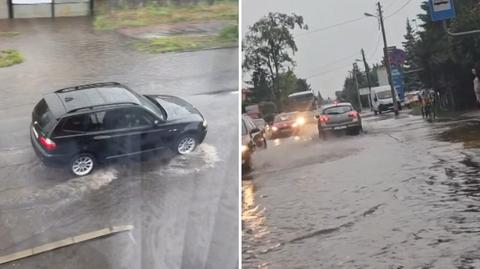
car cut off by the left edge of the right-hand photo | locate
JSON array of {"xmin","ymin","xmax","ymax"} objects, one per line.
[{"xmin": 242, "ymin": 114, "xmax": 263, "ymax": 171}]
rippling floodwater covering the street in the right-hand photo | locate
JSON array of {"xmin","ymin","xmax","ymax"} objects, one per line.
[{"xmin": 246, "ymin": 112, "xmax": 480, "ymax": 269}]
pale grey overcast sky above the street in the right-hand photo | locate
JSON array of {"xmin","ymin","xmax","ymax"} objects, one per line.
[{"xmin": 242, "ymin": 0, "xmax": 422, "ymax": 97}]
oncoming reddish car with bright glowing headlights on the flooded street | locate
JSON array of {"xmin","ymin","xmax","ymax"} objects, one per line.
[{"xmin": 271, "ymin": 112, "xmax": 306, "ymax": 139}]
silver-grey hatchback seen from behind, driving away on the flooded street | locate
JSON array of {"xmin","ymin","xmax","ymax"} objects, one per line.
[{"xmin": 317, "ymin": 103, "xmax": 363, "ymax": 139}]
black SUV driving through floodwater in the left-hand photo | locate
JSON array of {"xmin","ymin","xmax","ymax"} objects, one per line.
[{"xmin": 30, "ymin": 82, "xmax": 207, "ymax": 176}]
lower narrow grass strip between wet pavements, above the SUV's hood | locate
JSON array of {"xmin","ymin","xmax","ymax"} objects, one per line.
[{"xmin": 134, "ymin": 25, "xmax": 238, "ymax": 53}]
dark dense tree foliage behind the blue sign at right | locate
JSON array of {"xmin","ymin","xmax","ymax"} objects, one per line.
[{"xmin": 412, "ymin": 0, "xmax": 480, "ymax": 108}]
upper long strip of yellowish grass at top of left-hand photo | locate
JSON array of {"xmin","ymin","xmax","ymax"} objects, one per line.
[{"xmin": 93, "ymin": 1, "xmax": 238, "ymax": 31}]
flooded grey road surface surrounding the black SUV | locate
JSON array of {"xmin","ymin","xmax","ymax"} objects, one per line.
[{"xmin": 0, "ymin": 18, "xmax": 238, "ymax": 269}]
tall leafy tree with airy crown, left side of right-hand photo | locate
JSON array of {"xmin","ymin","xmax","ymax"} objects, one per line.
[{"xmin": 243, "ymin": 13, "xmax": 308, "ymax": 109}]
